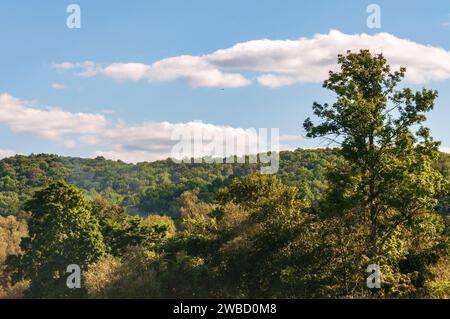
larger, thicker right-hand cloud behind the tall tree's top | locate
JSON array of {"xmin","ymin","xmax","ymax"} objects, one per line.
[{"xmin": 208, "ymin": 30, "xmax": 450, "ymax": 87}]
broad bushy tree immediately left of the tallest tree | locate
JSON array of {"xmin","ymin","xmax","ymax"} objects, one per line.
[{"xmin": 216, "ymin": 173, "xmax": 326, "ymax": 298}]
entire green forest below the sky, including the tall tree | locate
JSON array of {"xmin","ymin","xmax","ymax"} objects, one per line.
[{"xmin": 0, "ymin": 50, "xmax": 450, "ymax": 298}]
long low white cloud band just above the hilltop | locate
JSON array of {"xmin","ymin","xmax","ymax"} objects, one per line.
[{"xmin": 0, "ymin": 94, "xmax": 286, "ymax": 162}]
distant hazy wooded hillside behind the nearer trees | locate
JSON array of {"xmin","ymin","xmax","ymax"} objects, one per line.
[{"xmin": 0, "ymin": 150, "xmax": 339, "ymax": 218}]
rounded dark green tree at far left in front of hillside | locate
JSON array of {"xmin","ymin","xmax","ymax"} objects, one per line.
[{"xmin": 7, "ymin": 181, "xmax": 106, "ymax": 298}]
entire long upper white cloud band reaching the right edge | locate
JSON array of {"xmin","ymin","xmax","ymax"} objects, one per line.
[{"xmin": 54, "ymin": 30, "xmax": 450, "ymax": 88}]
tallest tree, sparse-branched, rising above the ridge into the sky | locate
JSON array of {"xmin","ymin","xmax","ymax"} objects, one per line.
[{"xmin": 303, "ymin": 50, "xmax": 446, "ymax": 292}]
